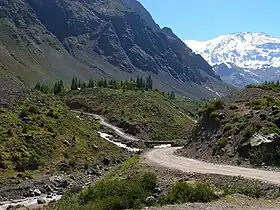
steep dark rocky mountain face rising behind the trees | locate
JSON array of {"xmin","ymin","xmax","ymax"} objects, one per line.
[{"xmin": 0, "ymin": 0, "xmax": 232, "ymax": 97}]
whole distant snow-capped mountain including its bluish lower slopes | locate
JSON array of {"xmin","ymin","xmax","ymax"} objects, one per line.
[{"xmin": 185, "ymin": 32, "xmax": 280, "ymax": 87}]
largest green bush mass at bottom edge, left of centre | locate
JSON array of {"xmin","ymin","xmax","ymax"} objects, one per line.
[{"xmin": 79, "ymin": 173, "xmax": 156, "ymax": 210}]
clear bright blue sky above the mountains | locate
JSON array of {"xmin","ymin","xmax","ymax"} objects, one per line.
[{"xmin": 139, "ymin": 0, "xmax": 280, "ymax": 41}]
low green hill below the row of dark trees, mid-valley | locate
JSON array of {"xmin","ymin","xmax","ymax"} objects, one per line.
[{"xmin": 65, "ymin": 88, "xmax": 197, "ymax": 140}]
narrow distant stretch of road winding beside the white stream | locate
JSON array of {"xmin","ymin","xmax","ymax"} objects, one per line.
[{"xmin": 71, "ymin": 110, "xmax": 140, "ymax": 141}]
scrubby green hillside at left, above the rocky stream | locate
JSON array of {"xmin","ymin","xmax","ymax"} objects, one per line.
[{"xmin": 0, "ymin": 91, "xmax": 121, "ymax": 177}]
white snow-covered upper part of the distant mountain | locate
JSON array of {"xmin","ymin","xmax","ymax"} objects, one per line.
[{"xmin": 185, "ymin": 32, "xmax": 280, "ymax": 69}]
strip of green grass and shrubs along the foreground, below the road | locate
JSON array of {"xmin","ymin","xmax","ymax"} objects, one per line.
[{"xmin": 47, "ymin": 155, "xmax": 272, "ymax": 210}]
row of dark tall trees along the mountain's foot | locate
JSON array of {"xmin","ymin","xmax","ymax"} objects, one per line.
[{"xmin": 35, "ymin": 75, "xmax": 176, "ymax": 99}]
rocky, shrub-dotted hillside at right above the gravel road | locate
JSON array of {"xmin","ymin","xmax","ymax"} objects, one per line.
[{"xmin": 178, "ymin": 84, "xmax": 280, "ymax": 167}]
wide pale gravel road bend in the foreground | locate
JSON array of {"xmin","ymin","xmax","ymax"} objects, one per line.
[{"xmin": 144, "ymin": 147, "xmax": 280, "ymax": 184}]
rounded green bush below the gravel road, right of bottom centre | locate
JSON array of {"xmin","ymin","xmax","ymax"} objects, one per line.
[{"xmin": 161, "ymin": 181, "xmax": 217, "ymax": 204}]
